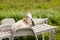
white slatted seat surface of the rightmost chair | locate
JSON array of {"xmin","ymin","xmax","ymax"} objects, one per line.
[{"xmin": 32, "ymin": 24, "xmax": 55, "ymax": 33}]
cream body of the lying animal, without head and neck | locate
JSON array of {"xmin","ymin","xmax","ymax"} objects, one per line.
[{"xmin": 11, "ymin": 20, "xmax": 29, "ymax": 30}]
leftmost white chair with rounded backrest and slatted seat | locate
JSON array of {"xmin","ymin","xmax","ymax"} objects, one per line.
[{"xmin": 0, "ymin": 18, "xmax": 15, "ymax": 40}]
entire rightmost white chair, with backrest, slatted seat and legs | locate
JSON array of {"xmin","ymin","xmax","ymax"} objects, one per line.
[{"xmin": 32, "ymin": 18, "xmax": 56, "ymax": 40}]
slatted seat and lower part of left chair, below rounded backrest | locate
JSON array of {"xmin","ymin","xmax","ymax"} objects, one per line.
[{"xmin": 0, "ymin": 25, "xmax": 12, "ymax": 40}]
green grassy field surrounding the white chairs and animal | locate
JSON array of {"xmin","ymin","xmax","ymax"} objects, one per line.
[{"xmin": 0, "ymin": 0, "xmax": 60, "ymax": 40}]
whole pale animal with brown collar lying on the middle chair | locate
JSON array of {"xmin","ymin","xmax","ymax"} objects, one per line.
[{"xmin": 11, "ymin": 14, "xmax": 33, "ymax": 31}]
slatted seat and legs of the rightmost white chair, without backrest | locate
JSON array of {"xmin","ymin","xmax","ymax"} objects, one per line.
[{"xmin": 31, "ymin": 24, "xmax": 55, "ymax": 40}]
